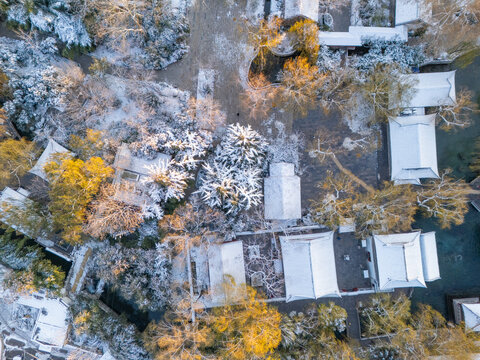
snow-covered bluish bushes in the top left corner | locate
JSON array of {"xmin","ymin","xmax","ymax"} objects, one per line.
[{"xmin": 7, "ymin": 0, "xmax": 92, "ymax": 47}]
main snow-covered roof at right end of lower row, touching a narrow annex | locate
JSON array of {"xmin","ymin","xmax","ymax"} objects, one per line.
[{"xmin": 373, "ymin": 231, "xmax": 427, "ymax": 290}]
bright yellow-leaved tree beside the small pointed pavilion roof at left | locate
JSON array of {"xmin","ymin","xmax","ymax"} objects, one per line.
[{"xmin": 44, "ymin": 154, "xmax": 113, "ymax": 244}]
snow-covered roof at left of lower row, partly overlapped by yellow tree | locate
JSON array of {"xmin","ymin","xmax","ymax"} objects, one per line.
[{"xmin": 208, "ymin": 241, "xmax": 246, "ymax": 302}]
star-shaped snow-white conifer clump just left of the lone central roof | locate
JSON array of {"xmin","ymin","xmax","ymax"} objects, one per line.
[{"xmin": 198, "ymin": 124, "xmax": 267, "ymax": 215}]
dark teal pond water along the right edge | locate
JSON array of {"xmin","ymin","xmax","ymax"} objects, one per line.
[{"xmin": 412, "ymin": 57, "xmax": 480, "ymax": 315}]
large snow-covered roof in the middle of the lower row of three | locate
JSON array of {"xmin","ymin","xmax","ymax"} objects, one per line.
[{"xmin": 280, "ymin": 231, "xmax": 340, "ymax": 302}]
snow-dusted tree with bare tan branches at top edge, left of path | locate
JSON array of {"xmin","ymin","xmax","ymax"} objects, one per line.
[{"xmin": 92, "ymin": 0, "xmax": 189, "ymax": 69}]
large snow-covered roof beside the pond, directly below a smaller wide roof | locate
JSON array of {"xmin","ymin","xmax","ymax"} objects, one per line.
[{"xmin": 389, "ymin": 114, "xmax": 438, "ymax": 184}]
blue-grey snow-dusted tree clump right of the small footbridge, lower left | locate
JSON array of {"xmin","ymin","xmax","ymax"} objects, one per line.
[{"xmin": 94, "ymin": 244, "xmax": 171, "ymax": 309}]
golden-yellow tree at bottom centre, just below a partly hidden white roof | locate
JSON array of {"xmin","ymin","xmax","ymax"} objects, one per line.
[{"xmin": 210, "ymin": 284, "xmax": 282, "ymax": 359}]
